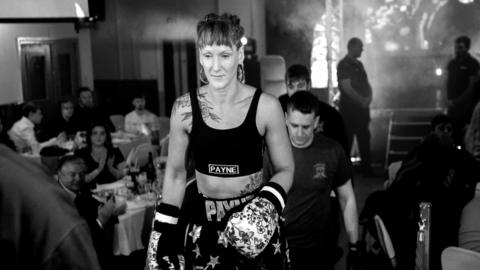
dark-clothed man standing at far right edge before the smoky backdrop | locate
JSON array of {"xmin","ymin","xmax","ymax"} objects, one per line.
[{"xmin": 447, "ymin": 36, "xmax": 479, "ymax": 144}]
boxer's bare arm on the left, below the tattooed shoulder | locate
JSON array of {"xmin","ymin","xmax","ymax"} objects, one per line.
[{"xmin": 162, "ymin": 95, "xmax": 191, "ymax": 208}]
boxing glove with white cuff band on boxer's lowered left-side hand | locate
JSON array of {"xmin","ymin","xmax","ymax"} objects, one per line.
[{"xmin": 147, "ymin": 203, "xmax": 185, "ymax": 270}]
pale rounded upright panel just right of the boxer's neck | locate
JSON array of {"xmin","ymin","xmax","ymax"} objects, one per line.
[{"xmin": 260, "ymin": 55, "xmax": 287, "ymax": 97}]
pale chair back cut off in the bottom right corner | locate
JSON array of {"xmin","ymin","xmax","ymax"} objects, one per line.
[{"xmin": 442, "ymin": 247, "xmax": 480, "ymax": 270}]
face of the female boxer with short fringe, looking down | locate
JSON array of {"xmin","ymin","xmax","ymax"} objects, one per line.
[{"xmin": 200, "ymin": 45, "xmax": 243, "ymax": 89}]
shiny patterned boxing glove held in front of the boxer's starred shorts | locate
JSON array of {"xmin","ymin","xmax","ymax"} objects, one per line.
[{"xmin": 224, "ymin": 182, "xmax": 286, "ymax": 259}]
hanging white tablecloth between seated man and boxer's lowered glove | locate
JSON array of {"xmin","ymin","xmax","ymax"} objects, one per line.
[{"xmin": 113, "ymin": 196, "xmax": 154, "ymax": 256}]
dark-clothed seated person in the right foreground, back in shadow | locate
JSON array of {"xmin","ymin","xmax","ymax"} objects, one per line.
[{"xmin": 381, "ymin": 114, "xmax": 480, "ymax": 269}]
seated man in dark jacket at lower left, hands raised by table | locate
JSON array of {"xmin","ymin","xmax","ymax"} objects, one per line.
[{"xmin": 57, "ymin": 155, "xmax": 126, "ymax": 270}]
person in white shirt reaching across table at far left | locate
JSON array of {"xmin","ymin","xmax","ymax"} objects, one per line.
[{"xmin": 8, "ymin": 103, "xmax": 65, "ymax": 155}]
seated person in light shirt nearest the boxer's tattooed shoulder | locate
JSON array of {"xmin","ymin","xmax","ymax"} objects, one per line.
[{"xmin": 125, "ymin": 94, "xmax": 158, "ymax": 136}]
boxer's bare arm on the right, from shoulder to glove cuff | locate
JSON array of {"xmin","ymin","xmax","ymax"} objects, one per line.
[{"xmin": 257, "ymin": 94, "xmax": 294, "ymax": 193}]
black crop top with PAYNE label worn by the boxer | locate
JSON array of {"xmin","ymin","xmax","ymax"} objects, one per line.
[{"xmin": 190, "ymin": 89, "xmax": 263, "ymax": 177}]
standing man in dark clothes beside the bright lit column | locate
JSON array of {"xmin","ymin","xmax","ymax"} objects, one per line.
[{"xmin": 337, "ymin": 37, "xmax": 372, "ymax": 174}]
